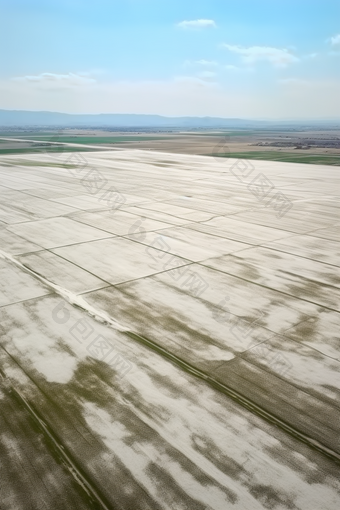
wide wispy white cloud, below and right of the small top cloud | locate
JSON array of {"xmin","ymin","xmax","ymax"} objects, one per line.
[{"xmin": 223, "ymin": 44, "xmax": 299, "ymax": 67}]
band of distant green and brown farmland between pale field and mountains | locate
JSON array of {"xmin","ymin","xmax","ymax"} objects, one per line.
[{"xmin": 0, "ymin": 128, "xmax": 340, "ymax": 166}]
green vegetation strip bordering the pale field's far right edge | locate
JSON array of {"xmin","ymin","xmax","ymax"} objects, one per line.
[{"xmin": 211, "ymin": 151, "xmax": 340, "ymax": 166}]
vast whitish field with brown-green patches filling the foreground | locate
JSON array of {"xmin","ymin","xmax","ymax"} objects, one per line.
[{"xmin": 0, "ymin": 149, "xmax": 340, "ymax": 510}]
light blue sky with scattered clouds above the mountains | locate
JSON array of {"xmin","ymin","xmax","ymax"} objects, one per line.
[{"xmin": 0, "ymin": 0, "xmax": 340, "ymax": 119}]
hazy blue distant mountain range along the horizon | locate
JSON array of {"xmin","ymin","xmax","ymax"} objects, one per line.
[{"xmin": 0, "ymin": 110, "xmax": 340, "ymax": 129}]
